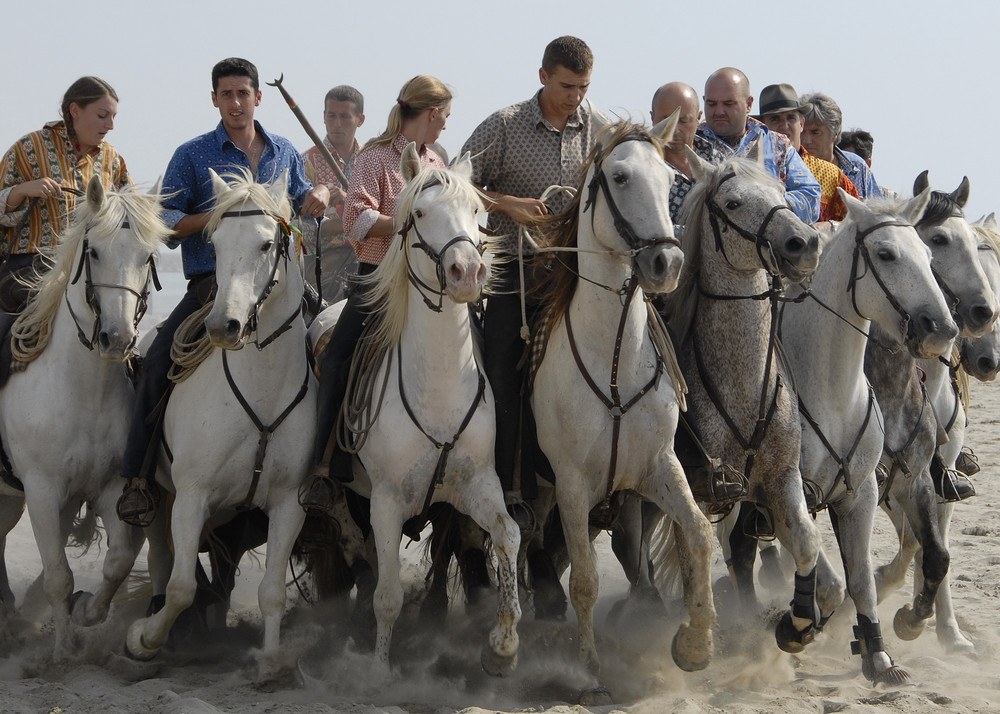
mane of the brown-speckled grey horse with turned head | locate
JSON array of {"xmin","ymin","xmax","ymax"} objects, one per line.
[{"xmin": 664, "ymin": 156, "xmax": 778, "ymax": 344}]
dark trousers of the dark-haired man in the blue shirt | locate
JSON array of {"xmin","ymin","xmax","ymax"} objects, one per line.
[{"xmin": 122, "ymin": 275, "xmax": 213, "ymax": 478}]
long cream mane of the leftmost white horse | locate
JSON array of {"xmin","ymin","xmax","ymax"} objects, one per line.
[{"xmin": 14, "ymin": 188, "xmax": 173, "ymax": 354}]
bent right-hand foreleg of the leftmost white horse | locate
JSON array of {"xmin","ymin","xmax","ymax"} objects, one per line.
[{"xmin": 71, "ymin": 484, "xmax": 144, "ymax": 626}]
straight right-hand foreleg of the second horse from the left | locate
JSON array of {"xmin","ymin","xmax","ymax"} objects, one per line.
[{"xmin": 257, "ymin": 491, "xmax": 306, "ymax": 657}]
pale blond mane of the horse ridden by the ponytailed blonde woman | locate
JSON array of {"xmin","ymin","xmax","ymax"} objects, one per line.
[{"xmin": 361, "ymin": 161, "xmax": 485, "ymax": 347}]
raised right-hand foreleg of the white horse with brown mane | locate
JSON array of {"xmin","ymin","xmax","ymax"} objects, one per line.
[{"xmin": 643, "ymin": 454, "xmax": 716, "ymax": 672}]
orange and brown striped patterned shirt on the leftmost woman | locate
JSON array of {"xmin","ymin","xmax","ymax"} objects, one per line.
[{"xmin": 0, "ymin": 121, "xmax": 132, "ymax": 254}]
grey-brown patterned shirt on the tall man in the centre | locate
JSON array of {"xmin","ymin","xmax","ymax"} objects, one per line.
[{"xmin": 461, "ymin": 90, "xmax": 594, "ymax": 253}]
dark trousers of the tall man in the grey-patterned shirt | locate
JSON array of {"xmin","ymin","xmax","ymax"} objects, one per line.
[{"xmin": 483, "ymin": 261, "xmax": 537, "ymax": 499}]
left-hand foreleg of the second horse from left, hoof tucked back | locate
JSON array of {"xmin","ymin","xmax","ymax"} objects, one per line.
[{"xmin": 125, "ymin": 492, "xmax": 208, "ymax": 659}]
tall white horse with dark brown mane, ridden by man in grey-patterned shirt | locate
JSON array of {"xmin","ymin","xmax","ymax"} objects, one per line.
[{"xmin": 531, "ymin": 118, "xmax": 716, "ymax": 676}]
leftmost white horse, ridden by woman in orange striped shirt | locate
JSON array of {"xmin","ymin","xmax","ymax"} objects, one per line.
[{"xmin": 0, "ymin": 178, "xmax": 170, "ymax": 659}]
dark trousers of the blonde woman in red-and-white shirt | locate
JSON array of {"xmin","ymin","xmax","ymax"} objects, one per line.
[{"xmin": 314, "ymin": 263, "xmax": 376, "ymax": 468}]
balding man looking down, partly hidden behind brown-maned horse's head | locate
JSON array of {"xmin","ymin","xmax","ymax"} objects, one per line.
[{"xmin": 649, "ymin": 82, "xmax": 723, "ymax": 221}]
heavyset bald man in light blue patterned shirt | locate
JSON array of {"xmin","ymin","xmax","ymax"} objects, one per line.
[{"xmin": 697, "ymin": 67, "xmax": 822, "ymax": 223}]
